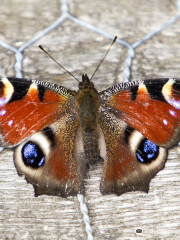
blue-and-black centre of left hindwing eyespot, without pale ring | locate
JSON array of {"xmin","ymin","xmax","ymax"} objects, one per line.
[{"xmin": 22, "ymin": 141, "xmax": 45, "ymax": 168}]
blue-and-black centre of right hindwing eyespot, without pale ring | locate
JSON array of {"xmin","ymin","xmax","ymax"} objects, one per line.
[{"xmin": 136, "ymin": 138, "xmax": 159, "ymax": 164}]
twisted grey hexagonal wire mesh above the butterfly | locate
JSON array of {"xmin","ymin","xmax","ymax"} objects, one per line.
[{"xmin": 0, "ymin": 0, "xmax": 180, "ymax": 82}]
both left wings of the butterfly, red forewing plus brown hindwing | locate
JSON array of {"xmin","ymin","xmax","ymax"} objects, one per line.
[{"xmin": 0, "ymin": 78, "xmax": 84, "ymax": 196}]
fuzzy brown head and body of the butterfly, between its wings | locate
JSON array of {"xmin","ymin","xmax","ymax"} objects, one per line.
[{"xmin": 76, "ymin": 75, "xmax": 100, "ymax": 164}]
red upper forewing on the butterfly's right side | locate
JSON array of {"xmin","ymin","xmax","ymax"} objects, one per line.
[{"xmin": 100, "ymin": 79, "xmax": 180, "ymax": 147}]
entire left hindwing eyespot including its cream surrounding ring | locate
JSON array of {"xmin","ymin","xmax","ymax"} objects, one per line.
[{"xmin": 14, "ymin": 128, "xmax": 53, "ymax": 179}]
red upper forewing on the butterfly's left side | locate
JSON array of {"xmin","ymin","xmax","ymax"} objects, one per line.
[{"xmin": 0, "ymin": 78, "xmax": 74, "ymax": 147}]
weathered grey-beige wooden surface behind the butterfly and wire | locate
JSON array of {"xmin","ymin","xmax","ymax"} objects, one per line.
[{"xmin": 0, "ymin": 0, "xmax": 180, "ymax": 240}]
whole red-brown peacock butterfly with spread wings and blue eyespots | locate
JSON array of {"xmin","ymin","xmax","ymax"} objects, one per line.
[{"xmin": 0, "ymin": 75, "xmax": 180, "ymax": 197}]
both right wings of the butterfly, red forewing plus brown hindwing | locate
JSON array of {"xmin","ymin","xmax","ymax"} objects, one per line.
[{"xmin": 100, "ymin": 79, "xmax": 180, "ymax": 195}]
